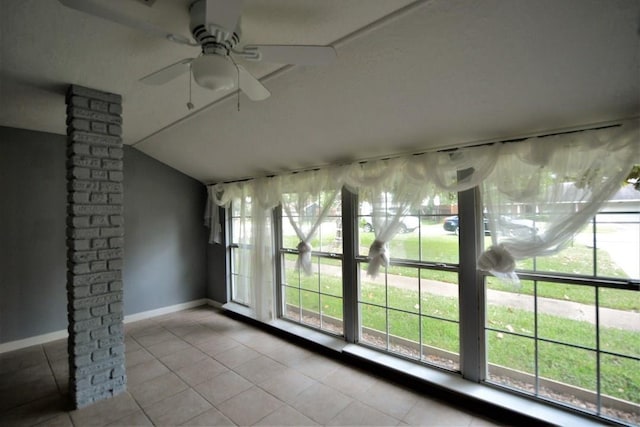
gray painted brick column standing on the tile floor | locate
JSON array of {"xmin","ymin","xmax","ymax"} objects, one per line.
[{"xmin": 66, "ymin": 85, "xmax": 127, "ymax": 408}]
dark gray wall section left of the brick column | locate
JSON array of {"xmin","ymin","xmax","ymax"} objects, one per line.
[{"xmin": 0, "ymin": 127, "xmax": 67, "ymax": 342}]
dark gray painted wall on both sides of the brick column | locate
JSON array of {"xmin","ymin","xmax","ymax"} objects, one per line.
[{"xmin": 0, "ymin": 127, "xmax": 210, "ymax": 343}]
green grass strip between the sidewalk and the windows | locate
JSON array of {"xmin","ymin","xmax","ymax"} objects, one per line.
[{"xmin": 285, "ymin": 269, "xmax": 640, "ymax": 403}]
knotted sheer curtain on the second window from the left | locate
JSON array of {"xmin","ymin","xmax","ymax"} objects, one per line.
[{"xmin": 282, "ymin": 169, "xmax": 342, "ymax": 275}]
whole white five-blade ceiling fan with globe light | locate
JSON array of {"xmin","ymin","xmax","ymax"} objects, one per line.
[{"xmin": 59, "ymin": 0, "xmax": 336, "ymax": 101}]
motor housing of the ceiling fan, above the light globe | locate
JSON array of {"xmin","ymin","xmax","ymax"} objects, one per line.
[{"xmin": 189, "ymin": 0, "xmax": 241, "ymax": 55}]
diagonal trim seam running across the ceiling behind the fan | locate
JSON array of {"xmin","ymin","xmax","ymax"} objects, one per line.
[{"xmin": 130, "ymin": 0, "xmax": 433, "ymax": 147}]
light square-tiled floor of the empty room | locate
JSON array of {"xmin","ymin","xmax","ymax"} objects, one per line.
[{"xmin": 0, "ymin": 306, "xmax": 504, "ymax": 427}]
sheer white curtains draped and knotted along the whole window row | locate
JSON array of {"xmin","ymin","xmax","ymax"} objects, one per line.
[{"xmin": 206, "ymin": 120, "xmax": 640, "ymax": 319}]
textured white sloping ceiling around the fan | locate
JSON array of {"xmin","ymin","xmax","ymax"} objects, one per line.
[{"xmin": 0, "ymin": 0, "xmax": 640, "ymax": 182}]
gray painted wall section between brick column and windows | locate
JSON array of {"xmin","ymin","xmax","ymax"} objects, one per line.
[{"xmin": 124, "ymin": 147, "xmax": 208, "ymax": 314}]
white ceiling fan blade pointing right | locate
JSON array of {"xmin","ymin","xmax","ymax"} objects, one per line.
[{"xmin": 245, "ymin": 45, "xmax": 336, "ymax": 65}]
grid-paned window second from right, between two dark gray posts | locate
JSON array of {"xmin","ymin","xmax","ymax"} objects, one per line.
[{"xmin": 357, "ymin": 193, "xmax": 460, "ymax": 370}]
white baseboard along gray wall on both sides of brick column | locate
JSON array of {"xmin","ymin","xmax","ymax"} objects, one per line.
[{"xmin": 0, "ymin": 298, "xmax": 222, "ymax": 354}]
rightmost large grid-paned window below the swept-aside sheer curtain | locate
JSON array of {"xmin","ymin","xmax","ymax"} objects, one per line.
[{"xmin": 486, "ymin": 198, "xmax": 640, "ymax": 423}]
